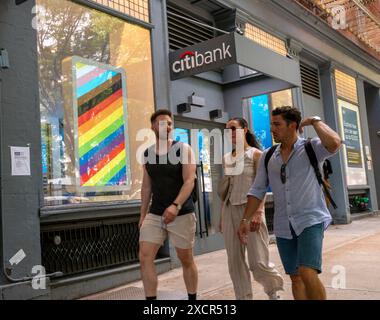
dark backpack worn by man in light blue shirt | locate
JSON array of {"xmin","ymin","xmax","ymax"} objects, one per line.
[{"xmin": 265, "ymin": 138, "xmax": 338, "ymax": 209}]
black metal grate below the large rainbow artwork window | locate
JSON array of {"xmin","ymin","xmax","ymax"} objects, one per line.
[{"xmin": 41, "ymin": 218, "xmax": 139, "ymax": 276}]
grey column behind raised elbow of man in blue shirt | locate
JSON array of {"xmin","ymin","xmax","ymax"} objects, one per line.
[{"xmin": 320, "ymin": 64, "xmax": 351, "ymax": 224}]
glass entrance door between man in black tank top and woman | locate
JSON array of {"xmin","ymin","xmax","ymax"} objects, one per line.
[{"xmin": 174, "ymin": 117, "xmax": 225, "ymax": 255}]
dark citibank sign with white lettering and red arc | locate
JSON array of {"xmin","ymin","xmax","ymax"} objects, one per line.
[{"xmin": 169, "ymin": 33, "xmax": 236, "ymax": 80}]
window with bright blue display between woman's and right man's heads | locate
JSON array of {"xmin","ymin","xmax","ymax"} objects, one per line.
[{"xmin": 243, "ymin": 89, "xmax": 293, "ymax": 149}]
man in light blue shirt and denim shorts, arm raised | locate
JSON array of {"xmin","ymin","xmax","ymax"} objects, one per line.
[{"xmin": 239, "ymin": 107, "xmax": 341, "ymax": 300}]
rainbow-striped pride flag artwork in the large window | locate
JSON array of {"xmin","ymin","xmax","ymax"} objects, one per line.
[{"xmin": 71, "ymin": 57, "xmax": 131, "ymax": 191}]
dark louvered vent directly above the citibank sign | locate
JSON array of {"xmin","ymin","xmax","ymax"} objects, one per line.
[{"xmin": 167, "ymin": 4, "xmax": 214, "ymax": 50}]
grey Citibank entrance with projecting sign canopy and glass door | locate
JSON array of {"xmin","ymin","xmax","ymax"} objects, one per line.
[{"xmin": 169, "ymin": 32, "xmax": 301, "ymax": 254}]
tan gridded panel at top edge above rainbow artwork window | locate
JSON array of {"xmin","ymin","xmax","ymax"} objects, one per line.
[{"xmin": 91, "ymin": 0, "xmax": 149, "ymax": 22}]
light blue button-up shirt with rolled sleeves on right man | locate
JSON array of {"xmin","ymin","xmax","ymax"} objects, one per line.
[{"xmin": 248, "ymin": 137, "xmax": 333, "ymax": 239}]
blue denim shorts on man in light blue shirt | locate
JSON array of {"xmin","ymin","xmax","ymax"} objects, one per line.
[{"xmin": 276, "ymin": 223, "xmax": 324, "ymax": 275}]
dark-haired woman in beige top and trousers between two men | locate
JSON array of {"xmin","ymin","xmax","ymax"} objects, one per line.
[{"xmin": 221, "ymin": 118, "xmax": 284, "ymax": 300}]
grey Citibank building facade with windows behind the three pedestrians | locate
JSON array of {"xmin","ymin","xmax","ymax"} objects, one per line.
[{"xmin": 0, "ymin": 0, "xmax": 380, "ymax": 299}]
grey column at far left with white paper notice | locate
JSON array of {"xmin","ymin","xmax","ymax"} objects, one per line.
[{"xmin": 0, "ymin": 0, "xmax": 49, "ymax": 299}]
